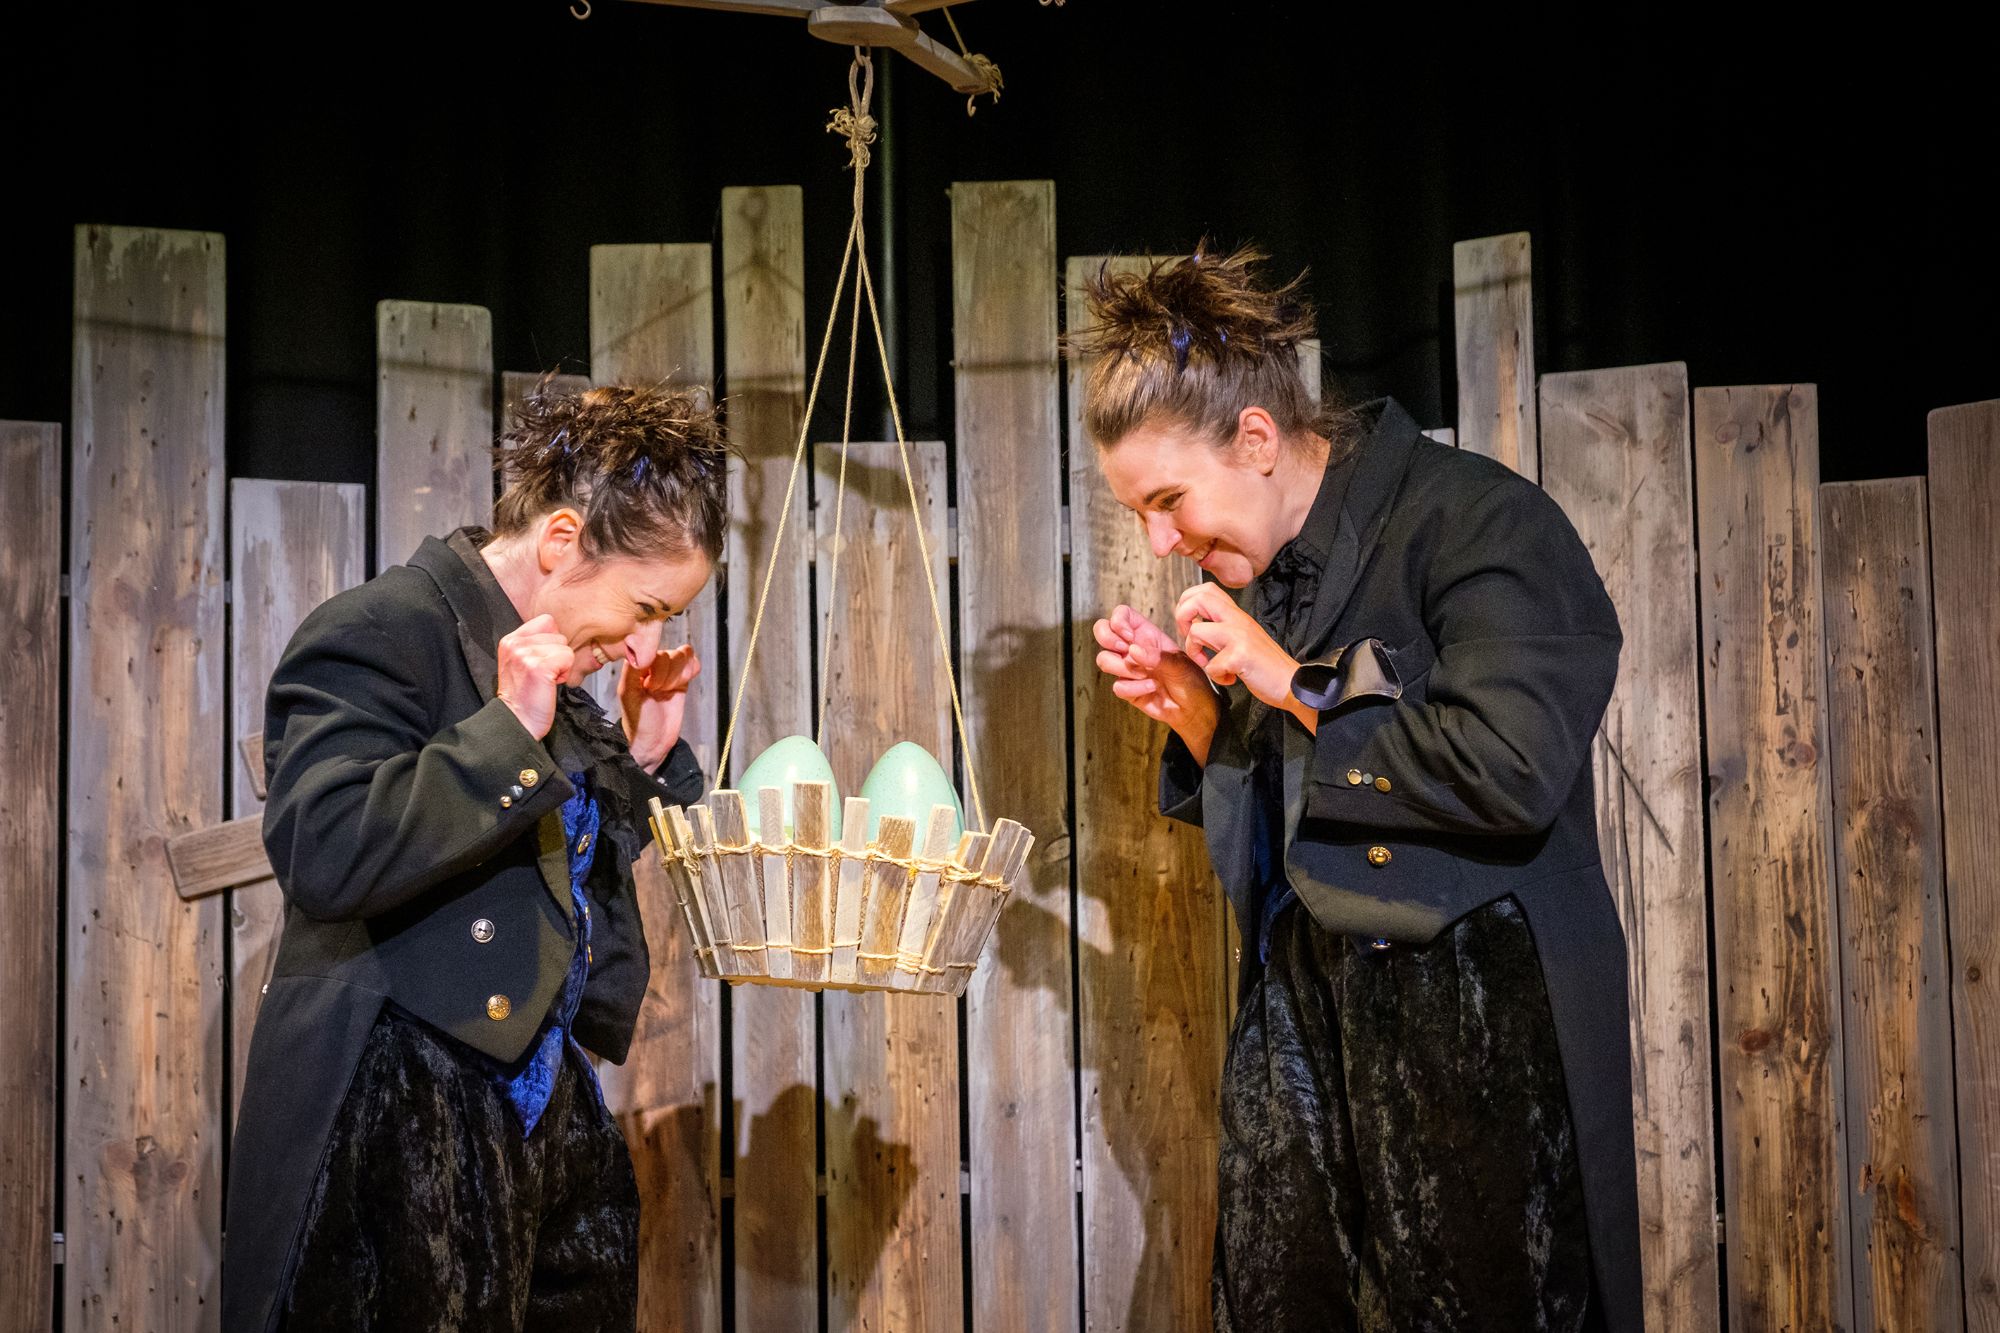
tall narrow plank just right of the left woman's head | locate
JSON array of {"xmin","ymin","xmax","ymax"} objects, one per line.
[{"xmin": 722, "ymin": 186, "xmax": 820, "ymax": 1333}]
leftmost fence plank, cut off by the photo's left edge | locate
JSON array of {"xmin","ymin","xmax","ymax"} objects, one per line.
[{"xmin": 0, "ymin": 420, "xmax": 62, "ymax": 1333}]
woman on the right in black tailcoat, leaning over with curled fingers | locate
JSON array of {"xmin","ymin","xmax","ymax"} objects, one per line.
[{"xmin": 1072, "ymin": 250, "xmax": 1640, "ymax": 1333}]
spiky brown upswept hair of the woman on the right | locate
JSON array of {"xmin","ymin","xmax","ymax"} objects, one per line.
[{"xmin": 1066, "ymin": 240, "xmax": 1348, "ymax": 452}]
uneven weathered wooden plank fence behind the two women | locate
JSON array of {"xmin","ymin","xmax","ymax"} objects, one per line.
[{"xmin": 0, "ymin": 200, "xmax": 2000, "ymax": 1333}]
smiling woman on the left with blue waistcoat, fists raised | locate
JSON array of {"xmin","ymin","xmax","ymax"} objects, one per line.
[{"xmin": 224, "ymin": 386, "xmax": 726, "ymax": 1331}]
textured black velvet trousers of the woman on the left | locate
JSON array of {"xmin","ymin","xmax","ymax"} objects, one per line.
[{"xmin": 280, "ymin": 1009, "xmax": 638, "ymax": 1333}]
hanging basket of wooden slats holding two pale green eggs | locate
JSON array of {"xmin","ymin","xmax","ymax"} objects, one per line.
[{"xmin": 652, "ymin": 783, "xmax": 1034, "ymax": 995}]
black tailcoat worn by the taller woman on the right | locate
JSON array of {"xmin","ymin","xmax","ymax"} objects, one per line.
[{"xmin": 1160, "ymin": 400, "xmax": 1642, "ymax": 1333}]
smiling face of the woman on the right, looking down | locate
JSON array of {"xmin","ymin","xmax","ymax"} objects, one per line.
[{"xmin": 1098, "ymin": 408, "xmax": 1312, "ymax": 588}]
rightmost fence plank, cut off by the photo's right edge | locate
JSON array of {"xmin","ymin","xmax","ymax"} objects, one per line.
[{"xmin": 1930, "ymin": 400, "xmax": 2000, "ymax": 1333}]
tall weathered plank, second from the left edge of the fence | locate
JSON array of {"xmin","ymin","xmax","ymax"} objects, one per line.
[{"xmin": 62, "ymin": 226, "xmax": 228, "ymax": 1331}]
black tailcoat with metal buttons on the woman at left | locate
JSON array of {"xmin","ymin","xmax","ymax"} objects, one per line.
[{"xmin": 222, "ymin": 530, "xmax": 702, "ymax": 1333}]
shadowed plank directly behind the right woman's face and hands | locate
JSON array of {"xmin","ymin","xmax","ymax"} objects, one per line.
[{"xmin": 1066, "ymin": 258, "xmax": 1230, "ymax": 1331}]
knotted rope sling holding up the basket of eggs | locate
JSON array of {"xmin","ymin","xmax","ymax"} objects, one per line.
[{"xmin": 716, "ymin": 46, "xmax": 986, "ymax": 829}]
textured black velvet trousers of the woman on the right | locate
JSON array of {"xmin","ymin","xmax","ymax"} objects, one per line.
[{"xmin": 1214, "ymin": 899, "xmax": 1590, "ymax": 1333}]
